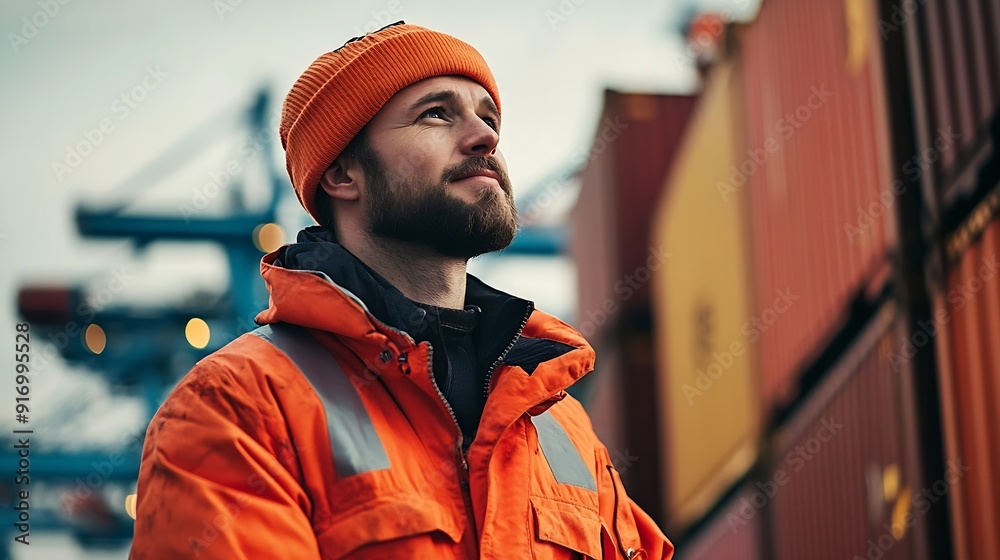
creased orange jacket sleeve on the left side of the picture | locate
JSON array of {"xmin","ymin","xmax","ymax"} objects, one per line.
[{"xmin": 129, "ymin": 361, "xmax": 320, "ymax": 560}]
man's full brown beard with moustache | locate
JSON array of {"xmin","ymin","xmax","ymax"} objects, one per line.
[{"xmin": 359, "ymin": 150, "xmax": 518, "ymax": 260}]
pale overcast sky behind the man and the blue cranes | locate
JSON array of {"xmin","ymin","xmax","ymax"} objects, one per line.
[{"xmin": 0, "ymin": 0, "xmax": 745, "ymax": 558}]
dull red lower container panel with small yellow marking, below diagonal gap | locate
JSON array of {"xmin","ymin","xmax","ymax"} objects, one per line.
[{"xmin": 764, "ymin": 302, "xmax": 928, "ymax": 560}]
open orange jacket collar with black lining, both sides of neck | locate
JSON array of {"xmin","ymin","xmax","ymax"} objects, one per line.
[{"xmin": 256, "ymin": 226, "xmax": 593, "ymax": 406}]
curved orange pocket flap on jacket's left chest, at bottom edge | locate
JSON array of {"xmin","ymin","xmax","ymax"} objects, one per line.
[{"xmin": 319, "ymin": 496, "xmax": 463, "ymax": 558}]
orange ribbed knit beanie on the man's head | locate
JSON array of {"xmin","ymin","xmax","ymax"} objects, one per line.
[{"xmin": 279, "ymin": 22, "xmax": 500, "ymax": 222}]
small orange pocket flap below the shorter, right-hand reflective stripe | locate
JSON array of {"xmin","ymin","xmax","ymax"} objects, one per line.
[{"xmin": 531, "ymin": 496, "xmax": 601, "ymax": 558}]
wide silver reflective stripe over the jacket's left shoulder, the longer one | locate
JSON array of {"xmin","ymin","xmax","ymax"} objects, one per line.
[{"xmin": 253, "ymin": 323, "xmax": 389, "ymax": 478}]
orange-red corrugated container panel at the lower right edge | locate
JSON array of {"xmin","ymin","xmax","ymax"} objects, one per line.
[{"xmin": 935, "ymin": 187, "xmax": 1000, "ymax": 560}]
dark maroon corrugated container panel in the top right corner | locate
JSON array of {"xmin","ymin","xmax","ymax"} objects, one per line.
[{"xmin": 900, "ymin": 0, "xmax": 1000, "ymax": 206}]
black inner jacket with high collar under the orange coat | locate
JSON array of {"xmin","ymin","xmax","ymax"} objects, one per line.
[{"xmin": 274, "ymin": 226, "xmax": 574, "ymax": 448}]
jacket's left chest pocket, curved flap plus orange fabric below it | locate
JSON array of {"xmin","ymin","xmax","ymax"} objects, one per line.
[{"xmin": 316, "ymin": 495, "xmax": 463, "ymax": 560}]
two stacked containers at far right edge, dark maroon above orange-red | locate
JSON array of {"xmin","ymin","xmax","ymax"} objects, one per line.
[{"xmin": 904, "ymin": 0, "xmax": 1000, "ymax": 560}]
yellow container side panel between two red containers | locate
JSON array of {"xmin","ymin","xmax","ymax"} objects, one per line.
[{"xmin": 650, "ymin": 62, "xmax": 761, "ymax": 532}]
